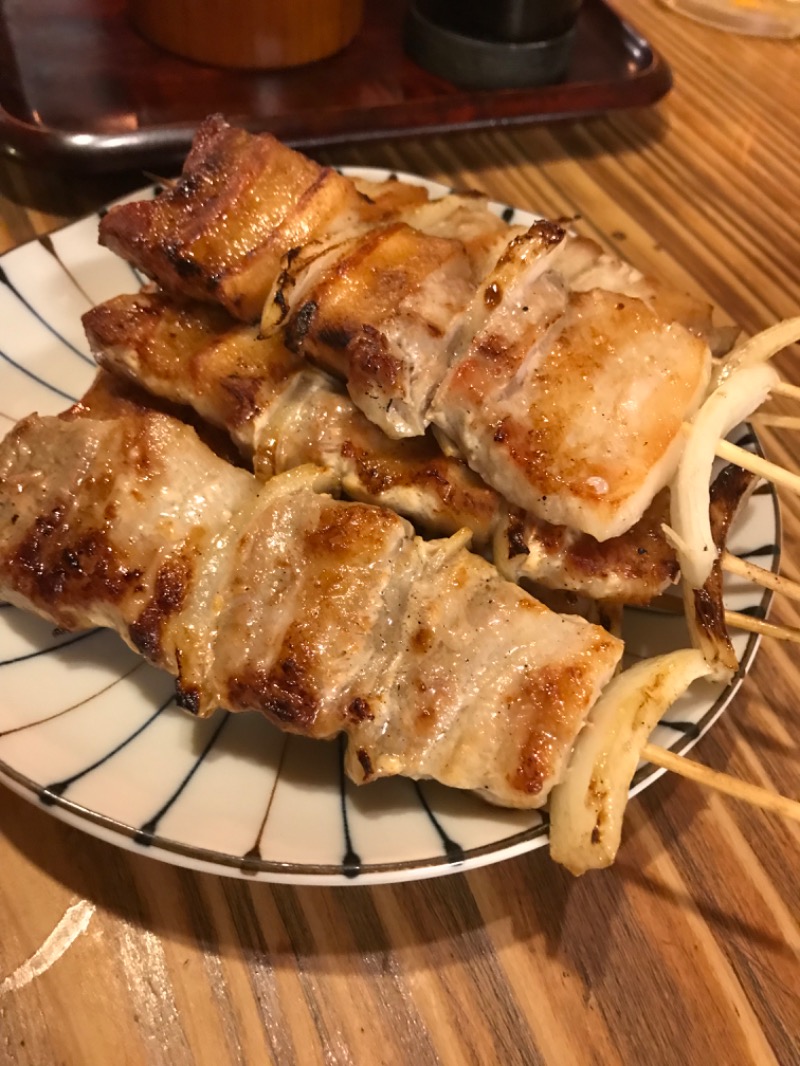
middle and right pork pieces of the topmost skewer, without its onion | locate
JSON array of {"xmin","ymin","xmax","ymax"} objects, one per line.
[{"xmin": 262, "ymin": 222, "xmax": 711, "ymax": 540}]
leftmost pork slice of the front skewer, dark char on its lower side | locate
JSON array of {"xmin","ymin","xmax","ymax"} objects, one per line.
[{"xmin": 0, "ymin": 408, "xmax": 253, "ymax": 707}]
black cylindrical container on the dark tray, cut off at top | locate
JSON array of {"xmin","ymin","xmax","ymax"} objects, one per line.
[{"xmin": 405, "ymin": 0, "xmax": 581, "ymax": 88}]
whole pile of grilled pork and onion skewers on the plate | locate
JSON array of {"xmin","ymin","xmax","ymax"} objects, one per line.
[{"xmin": 0, "ymin": 118, "xmax": 787, "ymax": 872}]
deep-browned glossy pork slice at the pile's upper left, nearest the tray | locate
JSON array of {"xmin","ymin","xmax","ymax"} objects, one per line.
[{"xmin": 100, "ymin": 115, "xmax": 363, "ymax": 321}]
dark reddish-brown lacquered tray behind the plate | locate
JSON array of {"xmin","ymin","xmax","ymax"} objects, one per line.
[{"xmin": 0, "ymin": 0, "xmax": 671, "ymax": 171}]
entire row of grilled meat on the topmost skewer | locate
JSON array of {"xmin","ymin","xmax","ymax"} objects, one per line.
[{"xmin": 101, "ymin": 119, "xmax": 791, "ymax": 601}]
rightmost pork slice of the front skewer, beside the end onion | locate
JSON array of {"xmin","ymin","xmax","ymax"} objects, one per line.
[{"xmin": 347, "ymin": 528, "xmax": 621, "ymax": 807}]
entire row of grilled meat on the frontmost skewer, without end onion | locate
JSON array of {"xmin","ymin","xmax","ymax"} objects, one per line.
[{"xmin": 0, "ymin": 414, "xmax": 619, "ymax": 806}]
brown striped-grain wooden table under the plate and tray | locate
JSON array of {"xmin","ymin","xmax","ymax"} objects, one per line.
[{"xmin": 0, "ymin": 0, "xmax": 800, "ymax": 1066}]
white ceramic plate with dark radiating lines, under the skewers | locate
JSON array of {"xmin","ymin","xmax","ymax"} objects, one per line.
[{"xmin": 0, "ymin": 171, "xmax": 779, "ymax": 884}]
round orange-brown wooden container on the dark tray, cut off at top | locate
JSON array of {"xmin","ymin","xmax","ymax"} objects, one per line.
[{"xmin": 130, "ymin": 0, "xmax": 364, "ymax": 69}]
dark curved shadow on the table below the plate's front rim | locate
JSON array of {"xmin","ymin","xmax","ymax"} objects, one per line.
[{"xmin": 0, "ymin": 741, "xmax": 794, "ymax": 987}]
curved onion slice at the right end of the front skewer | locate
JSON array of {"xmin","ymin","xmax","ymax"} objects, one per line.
[{"xmin": 549, "ymin": 648, "xmax": 710, "ymax": 875}]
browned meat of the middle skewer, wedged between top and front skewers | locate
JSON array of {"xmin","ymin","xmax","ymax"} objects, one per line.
[{"xmin": 83, "ymin": 293, "xmax": 499, "ymax": 545}]
